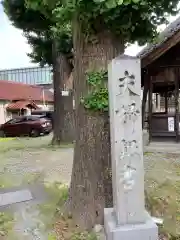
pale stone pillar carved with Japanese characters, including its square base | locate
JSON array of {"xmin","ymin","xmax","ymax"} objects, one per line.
[{"xmin": 104, "ymin": 55, "xmax": 158, "ymax": 240}]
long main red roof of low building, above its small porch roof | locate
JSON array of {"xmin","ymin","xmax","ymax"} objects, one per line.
[{"xmin": 0, "ymin": 80, "xmax": 53, "ymax": 102}]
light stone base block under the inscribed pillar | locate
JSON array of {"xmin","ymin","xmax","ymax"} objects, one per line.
[{"xmin": 104, "ymin": 208, "xmax": 158, "ymax": 240}]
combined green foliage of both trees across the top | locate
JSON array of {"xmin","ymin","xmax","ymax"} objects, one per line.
[{"xmin": 2, "ymin": 0, "xmax": 179, "ymax": 65}]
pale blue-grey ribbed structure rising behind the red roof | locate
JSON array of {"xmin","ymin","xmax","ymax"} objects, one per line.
[{"xmin": 0, "ymin": 67, "xmax": 53, "ymax": 85}]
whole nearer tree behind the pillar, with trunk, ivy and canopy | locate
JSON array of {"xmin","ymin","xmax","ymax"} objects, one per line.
[{"xmin": 27, "ymin": 0, "xmax": 178, "ymax": 229}]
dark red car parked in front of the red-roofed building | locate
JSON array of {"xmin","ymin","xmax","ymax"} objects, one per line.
[{"xmin": 0, "ymin": 116, "xmax": 52, "ymax": 137}]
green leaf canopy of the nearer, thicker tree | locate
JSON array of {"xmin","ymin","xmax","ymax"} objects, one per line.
[{"xmin": 26, "ymin": 0, "xmax": 179, "ymax": 44}]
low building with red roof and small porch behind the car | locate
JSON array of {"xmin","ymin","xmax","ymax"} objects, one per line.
[{"xmin": 0, "ymin": 80, "xmax": 54, "ymax": 124}]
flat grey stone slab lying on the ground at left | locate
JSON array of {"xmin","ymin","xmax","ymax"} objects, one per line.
[{"xmin": 0, "ymin": 189, "xmax": 33, "ymax": 207}]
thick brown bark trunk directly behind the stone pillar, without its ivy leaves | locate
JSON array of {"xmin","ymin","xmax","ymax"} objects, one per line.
[{"xmin": 69, "ymin": 19, "xmax": 124, "ymax": 230}]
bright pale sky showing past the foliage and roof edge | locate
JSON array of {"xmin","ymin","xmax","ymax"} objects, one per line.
[{"xmin": 0, "ymin": 4, "xmax": 179, "ymax": 69}]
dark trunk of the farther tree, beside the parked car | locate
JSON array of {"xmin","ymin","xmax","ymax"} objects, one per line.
[{"xmin": 52, "ymin": 41, "xmax": 72, "ymax": 145}]
